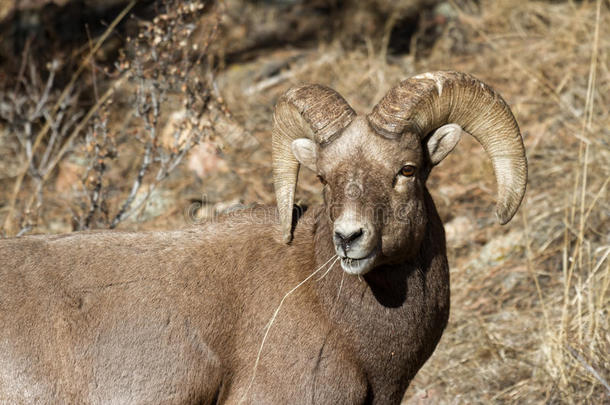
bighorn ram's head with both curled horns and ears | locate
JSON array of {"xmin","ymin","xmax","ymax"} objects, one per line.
[{"xmin": 273, "ymin": 72, "xmax": 527, "ymax": 274}]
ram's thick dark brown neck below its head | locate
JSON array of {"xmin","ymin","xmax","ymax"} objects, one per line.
[{"xmin": 311, "ymin": 196, "xmax": 449, "ymax": 402}]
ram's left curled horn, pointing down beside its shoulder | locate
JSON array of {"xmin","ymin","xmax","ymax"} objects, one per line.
[{"xmin": 272, "ymin": 85, "xmax": 356, "ymax": 243}]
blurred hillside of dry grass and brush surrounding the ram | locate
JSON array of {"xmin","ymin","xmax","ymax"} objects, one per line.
[{"xmin": 0, "ymin": 0, "xmax": 610, "ymax": 404}]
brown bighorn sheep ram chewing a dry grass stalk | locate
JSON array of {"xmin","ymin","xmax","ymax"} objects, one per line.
[{"xmin": 0, "ymin": 72, "xmax": 527, "ymax": 404}]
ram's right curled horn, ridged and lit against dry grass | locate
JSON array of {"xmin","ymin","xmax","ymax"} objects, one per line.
[{"xmin": 368, "ymin": 72, "xmax": 527, "ymax": 224}]
